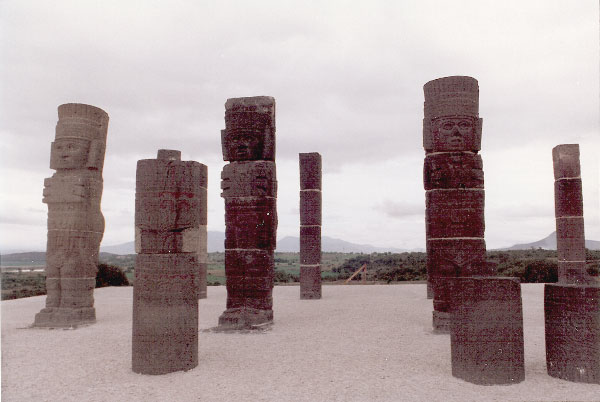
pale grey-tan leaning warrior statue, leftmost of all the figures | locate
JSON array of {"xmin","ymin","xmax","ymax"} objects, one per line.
[{"xmin": 33, "ymin": 103, "xmax": 108, "ymax": 327}]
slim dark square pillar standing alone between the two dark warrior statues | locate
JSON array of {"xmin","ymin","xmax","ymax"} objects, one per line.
[{"xmin": 299, "ymin": 152, "xmax": 322, "ymax": 299}]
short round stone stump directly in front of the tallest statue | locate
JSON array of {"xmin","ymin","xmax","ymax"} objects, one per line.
[{"xmin": 450, "ymin": 277, "xmax": 525, "ymax": 385}]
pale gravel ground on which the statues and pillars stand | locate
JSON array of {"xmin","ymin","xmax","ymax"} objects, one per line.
[{"xmin": 1, "ymin": 284, "xmax": 600, "ymax": 401}]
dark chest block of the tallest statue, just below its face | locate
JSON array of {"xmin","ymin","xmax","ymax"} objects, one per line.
[{"xmin": 423, "ymin": 152, "xmax": 483, "ymax": 190}]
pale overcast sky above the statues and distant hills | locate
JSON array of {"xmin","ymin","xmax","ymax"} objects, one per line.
[{"xmin": 0, "ymin": 0, "xmax": 600, "ymax": 252}]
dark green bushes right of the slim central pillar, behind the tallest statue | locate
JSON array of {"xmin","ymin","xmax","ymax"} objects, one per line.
[{"xmin": 332, "ymin": 249, "xmax": 600, "ymax": 283}]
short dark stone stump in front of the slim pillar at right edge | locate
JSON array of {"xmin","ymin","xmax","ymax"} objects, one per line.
[{"xmin": 544, "ymin": 284, "xmax": 600, "ymax": 384}]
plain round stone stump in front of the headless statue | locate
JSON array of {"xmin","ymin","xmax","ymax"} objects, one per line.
[{"xmin": 132, "ymin": 253, "xmax": 198, "ymax": 374}]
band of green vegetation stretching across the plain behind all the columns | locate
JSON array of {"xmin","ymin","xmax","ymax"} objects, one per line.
[{"xmin": 1, "ymin": 249, "xmax": 600, "ymax": 300}]
